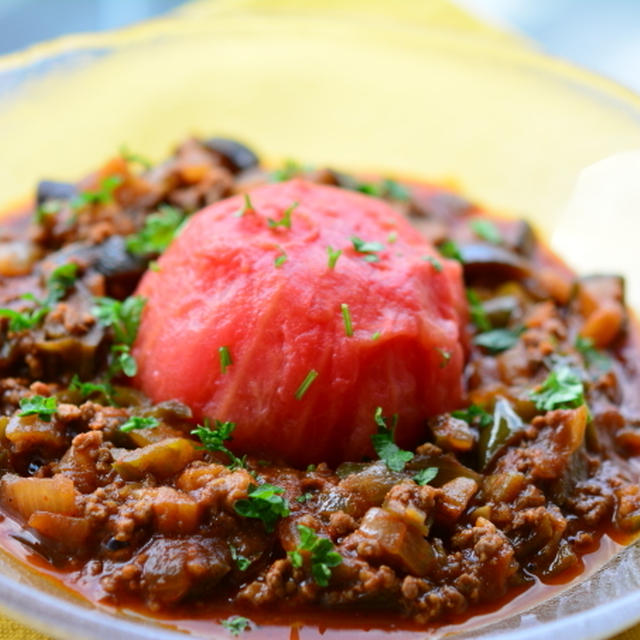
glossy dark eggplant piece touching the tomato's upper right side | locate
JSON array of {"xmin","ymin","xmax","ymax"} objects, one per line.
[{"xmin": 459, "ymin": 243, "xmax": 534, "ymax": 282}]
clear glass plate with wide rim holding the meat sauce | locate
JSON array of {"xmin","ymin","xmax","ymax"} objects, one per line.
[{"xmin": 0, "ymin": 0, "xmax": 640, "ymax": 640}]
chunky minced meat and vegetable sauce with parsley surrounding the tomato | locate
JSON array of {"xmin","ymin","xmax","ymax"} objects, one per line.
[{"xmin": 0, "ymin": 138, "xmax": 640, "ymax": 633}]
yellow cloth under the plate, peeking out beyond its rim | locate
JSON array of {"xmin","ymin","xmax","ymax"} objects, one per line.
[{"xmin": 0, "ymin": 0, "xmax": 640, "ymax": 640}]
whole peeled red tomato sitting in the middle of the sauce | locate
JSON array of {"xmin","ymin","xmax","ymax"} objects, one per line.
[{"xmin": 133, "ymin": 180, "xmax": 467, "ymax": 465}]
